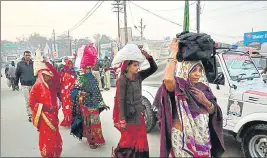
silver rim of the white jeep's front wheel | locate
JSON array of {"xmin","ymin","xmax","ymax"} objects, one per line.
[{"xmin": 249, "ymin": 135, "xmax": 267, "ymax": 157}]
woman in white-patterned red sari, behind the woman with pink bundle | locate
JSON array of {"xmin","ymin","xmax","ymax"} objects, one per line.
[{"xmin": 60, "ymin": 59, "xmax": 76, "ymax": 127}]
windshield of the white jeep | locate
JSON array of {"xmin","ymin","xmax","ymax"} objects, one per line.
[{"xmin": 223, "ymin": 52, "xmax": 260, "ymax": 81}]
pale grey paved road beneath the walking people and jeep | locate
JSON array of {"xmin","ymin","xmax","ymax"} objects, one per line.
[{"xmin": 1, "ymin": 71, "xmax": 243, "ymax": 157}]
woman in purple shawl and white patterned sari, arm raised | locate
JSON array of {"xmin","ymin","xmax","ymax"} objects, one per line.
[{"xmin": 154, "ymin": 40, "xmax": 224, "ymax": 158}]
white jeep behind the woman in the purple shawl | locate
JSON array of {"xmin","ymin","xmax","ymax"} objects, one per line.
[{"xmin": 142, "ymin": 49, "xmax": 267, "ymax": 157}]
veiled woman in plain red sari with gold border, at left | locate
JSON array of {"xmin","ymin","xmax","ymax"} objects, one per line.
[{"xmin": 29, "ymin": 56, "xmax": 63, "ymax": 157}]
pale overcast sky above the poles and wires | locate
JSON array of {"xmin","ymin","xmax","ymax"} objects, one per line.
[{"xmin": 1, "ymin": 1, "xmax": 267, "ymax": 43}]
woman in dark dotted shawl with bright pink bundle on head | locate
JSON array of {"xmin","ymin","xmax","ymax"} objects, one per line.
[{"xmin": 71, "ymin": 45, "xmax": 109, "ymax": 149}]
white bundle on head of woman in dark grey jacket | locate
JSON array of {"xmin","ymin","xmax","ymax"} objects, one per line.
[{"xmin": 112, "ymin": 44, "xmax": 145, "ymax": 66}]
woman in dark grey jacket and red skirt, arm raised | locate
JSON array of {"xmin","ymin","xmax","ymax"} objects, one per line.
[{"xmin": 112, "ymin": 47, "xmax": 158, "ymax": 158}]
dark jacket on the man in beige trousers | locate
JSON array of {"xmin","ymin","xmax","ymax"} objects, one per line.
[{"xmin": 16, "ymin": 58, "xmax": 36, "ymax": 86}]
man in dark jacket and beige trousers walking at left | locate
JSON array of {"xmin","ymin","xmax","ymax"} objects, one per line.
[{"xmin": 16, "ymin": 51, "xmax": 35, "ymax": 122}]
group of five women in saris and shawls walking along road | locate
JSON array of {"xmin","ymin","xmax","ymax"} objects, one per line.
[{"xmin": 16, "ymin": 39, "xmax": 224, "ymax": 158}]
